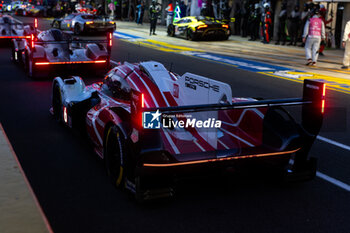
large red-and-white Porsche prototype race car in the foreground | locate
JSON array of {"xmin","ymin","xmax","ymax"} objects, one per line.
[{"xmin": 51, "ymin": 61, "xmax": 325, "ymax": 200}]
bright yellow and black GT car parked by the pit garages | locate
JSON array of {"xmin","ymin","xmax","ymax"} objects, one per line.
[{"xmin": 168, "ymin": 16, "xmax": 234, "ymax": 40}]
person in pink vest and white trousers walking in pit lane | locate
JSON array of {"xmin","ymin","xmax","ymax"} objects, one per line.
[{"xmin": 303, "ymin": 8, "xmax": 325, "ymax": 66}]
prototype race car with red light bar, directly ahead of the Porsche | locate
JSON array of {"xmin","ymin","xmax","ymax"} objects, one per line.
[{"xmin": 12, "ymin": 29, "xmax": 113, "ymax": 78}]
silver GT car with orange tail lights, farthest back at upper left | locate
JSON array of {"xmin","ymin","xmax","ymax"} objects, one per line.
[{"xmin": 52, "ymin": 13, "xmax": 116, "ymax": 35}]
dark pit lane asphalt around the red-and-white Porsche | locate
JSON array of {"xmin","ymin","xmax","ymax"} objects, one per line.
[{"xmin": 0, "ymin": 16, "xmax": 350, "ymax": 233}]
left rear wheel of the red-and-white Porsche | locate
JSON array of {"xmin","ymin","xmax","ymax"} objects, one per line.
[{"xmin": 104, "ymin": 126, "xmax": 125, "ymax": 188}]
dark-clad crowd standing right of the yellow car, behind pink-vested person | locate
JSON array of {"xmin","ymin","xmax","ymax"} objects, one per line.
[{"xmin": 234, "ymin": 2, "xmax": 332, "ymax": 46}]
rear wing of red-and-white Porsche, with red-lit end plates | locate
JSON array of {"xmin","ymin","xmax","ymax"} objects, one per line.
[{"xmin": 131, "ymin": 79, "xmax": 326, "ymax": 136}]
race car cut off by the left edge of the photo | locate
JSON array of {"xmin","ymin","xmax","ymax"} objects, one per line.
[{"xmin": 0, "ymin": 14, "xmax": 35, "ymax": 42}]
